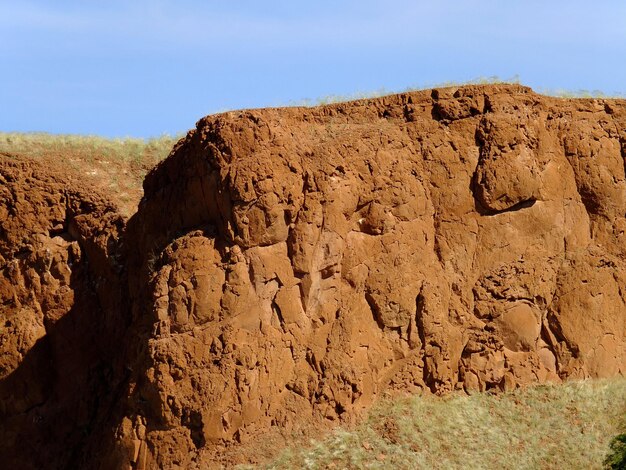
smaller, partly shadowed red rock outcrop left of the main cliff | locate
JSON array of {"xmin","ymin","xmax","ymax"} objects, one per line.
[{"xmin": 0, "ymin": 156, "xmax": 129, "ymax": 469}]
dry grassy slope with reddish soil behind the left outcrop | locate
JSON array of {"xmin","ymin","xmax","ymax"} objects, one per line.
[{"xmin": 0, "ymin": 132, "xmax": 178, "ymax": 216}]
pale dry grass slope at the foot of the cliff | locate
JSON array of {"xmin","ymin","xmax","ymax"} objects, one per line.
[{"xmin": 251, "ymin": 378, "xmax": 626, "ymax": 469}]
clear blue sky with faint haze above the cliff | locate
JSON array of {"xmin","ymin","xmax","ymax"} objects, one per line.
[{"xmin": 0, "ymin": 0, "xmax": 626, "ymax": 137}]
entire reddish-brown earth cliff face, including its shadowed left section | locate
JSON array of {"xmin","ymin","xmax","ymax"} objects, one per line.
[{"xmin": 0, "ymin": 85, "xmax": 626, "ymax": 468}]
